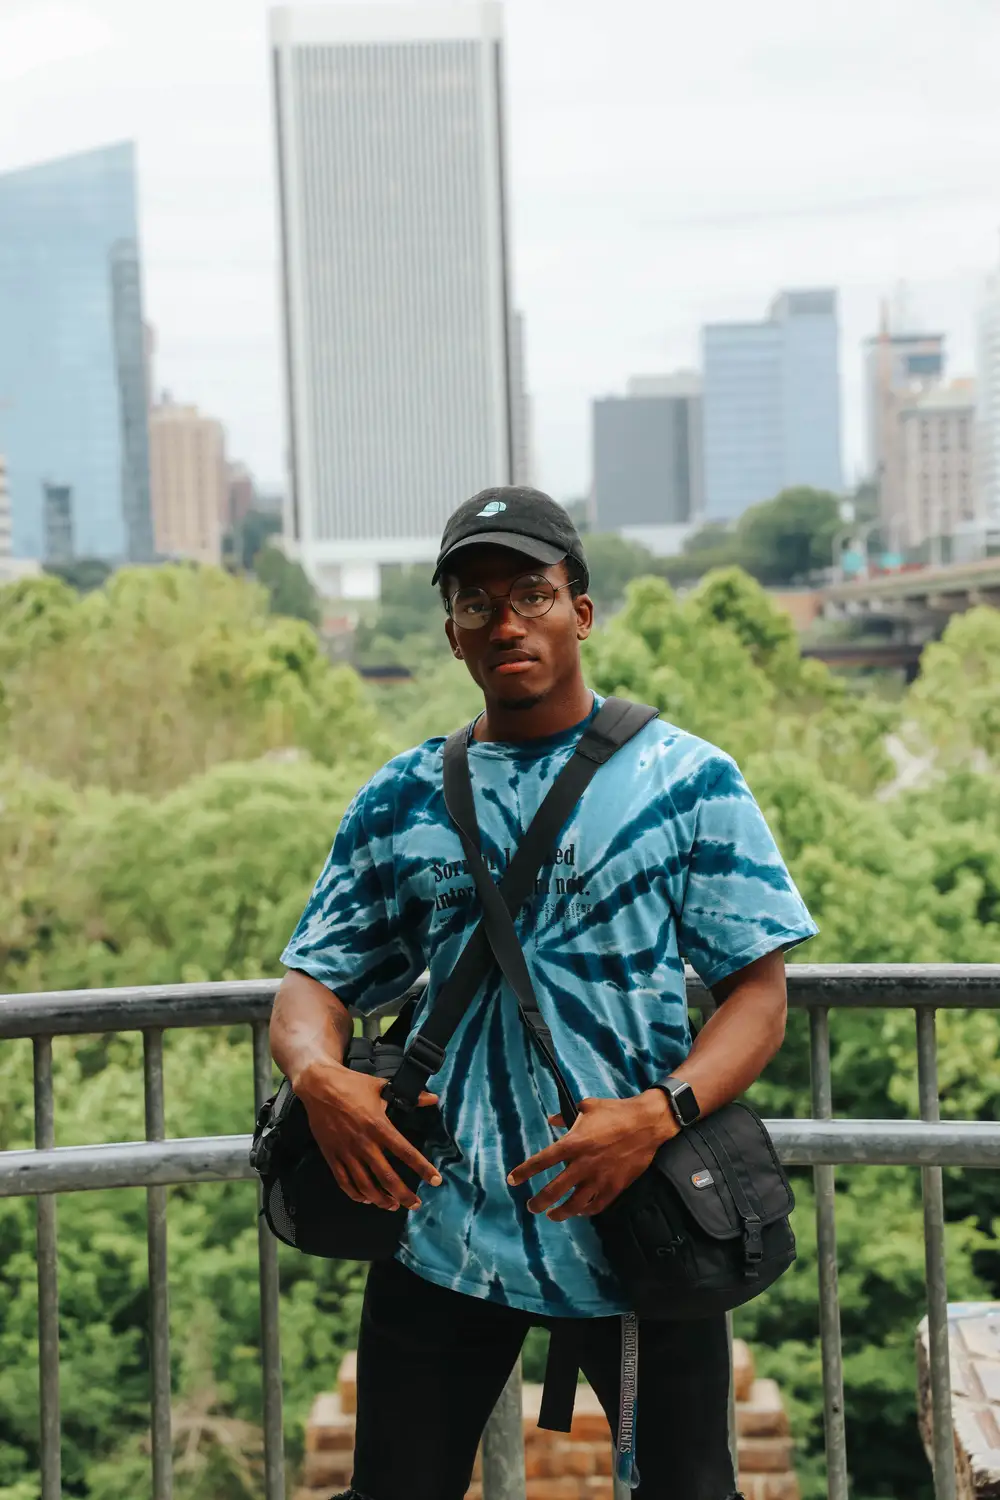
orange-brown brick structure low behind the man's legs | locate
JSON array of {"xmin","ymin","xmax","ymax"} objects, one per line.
[{"xmin": 295, "ymin": 1340, "xmax": 799, "ymax": 1500}]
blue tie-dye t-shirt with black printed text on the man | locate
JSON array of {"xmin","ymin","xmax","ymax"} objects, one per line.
[{"xmin": 282, "ymin": 701, "xmax": 817, "ymax": 1317}]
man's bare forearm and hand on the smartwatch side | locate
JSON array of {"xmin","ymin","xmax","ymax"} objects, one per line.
[{"xmin": 507, "ymin": 948, "xmax": 787, "ymax": 1221}]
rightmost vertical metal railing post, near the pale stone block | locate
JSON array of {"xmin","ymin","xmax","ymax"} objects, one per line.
[{"xmin": 916, "ymin": 1005, "xmax": 955, "ymax": 1500}]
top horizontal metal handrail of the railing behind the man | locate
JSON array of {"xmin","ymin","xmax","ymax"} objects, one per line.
[{"xmin": 0, "ymin": 963, "xmax": 1000, "ymax": 1040}]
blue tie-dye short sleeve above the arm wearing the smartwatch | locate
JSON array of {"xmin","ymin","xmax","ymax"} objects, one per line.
[{"xmin": 678, "ymin": 756, "xmax": 819, "ymax": 986}]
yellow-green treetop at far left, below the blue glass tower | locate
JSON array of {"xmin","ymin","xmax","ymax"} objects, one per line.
[{"xmin": 0, "ymin": 566, "xmax": 382, "ymax": 792}]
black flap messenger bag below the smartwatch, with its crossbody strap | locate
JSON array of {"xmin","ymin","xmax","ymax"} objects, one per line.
[{"xmin": 444, "ymin": 726, "xmax": 795, "ymax": 1320}]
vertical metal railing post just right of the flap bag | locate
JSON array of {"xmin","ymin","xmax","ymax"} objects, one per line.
[{"xmin": 810, "ymin": 1005, "xmax": 847, "ymax": 1500}]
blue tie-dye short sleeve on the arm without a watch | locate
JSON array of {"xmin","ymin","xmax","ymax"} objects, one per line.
[{"xmin": 282, "ymin": 788, "xmax": 424, "ymax": 1016}]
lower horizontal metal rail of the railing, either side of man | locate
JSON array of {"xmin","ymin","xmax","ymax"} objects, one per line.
[{"xmin": 0, "ymin": 1121, "xmax": 1000, "ymax": 1199}]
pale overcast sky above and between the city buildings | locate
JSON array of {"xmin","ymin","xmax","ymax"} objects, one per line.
[{"xmin": 0, "ymin": 0, "xmax": 1000, "ymax": 498}]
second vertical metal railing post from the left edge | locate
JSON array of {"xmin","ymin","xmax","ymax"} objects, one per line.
[{"xmin": 142, "ymin": 1029, "xmax": 174, "ymax": 1500}]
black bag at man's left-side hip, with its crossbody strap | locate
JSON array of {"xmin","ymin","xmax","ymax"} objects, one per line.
[{"xmin": 250, "ymin": 698, "xmax": 657, "ymax": 1260}]
